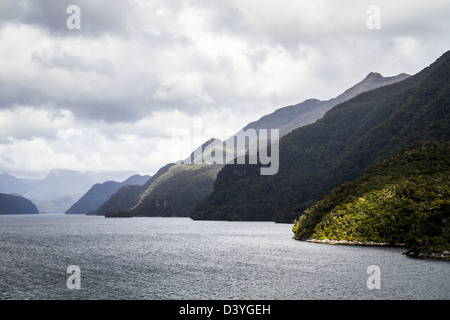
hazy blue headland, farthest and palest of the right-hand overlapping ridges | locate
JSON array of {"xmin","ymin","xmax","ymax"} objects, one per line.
[{"xmin": 66, "ymin": 174, "xmax": 150, "ymax": 214}]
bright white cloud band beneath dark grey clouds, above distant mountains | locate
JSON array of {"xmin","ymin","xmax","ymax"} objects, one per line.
[{"xmin": 0, "ymin": 107, "xmax": 255, "ymax": 174}]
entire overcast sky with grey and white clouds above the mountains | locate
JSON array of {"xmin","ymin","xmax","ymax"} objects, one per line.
[{"xmin": 0, "ymin": 0, "xmax": 450, "ymax": 178}]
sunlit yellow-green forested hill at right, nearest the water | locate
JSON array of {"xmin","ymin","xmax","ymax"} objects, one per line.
[{"xmin": 293, "ymin": 143, "xmax": 450, "ymax": 253}]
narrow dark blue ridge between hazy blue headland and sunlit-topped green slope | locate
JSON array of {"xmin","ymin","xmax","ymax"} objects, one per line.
[{"xmin": 89, "ymin": 163, "xmax": 175, "ymax": 216}]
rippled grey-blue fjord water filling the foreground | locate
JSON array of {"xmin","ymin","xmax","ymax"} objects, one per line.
[{"xmin": 0, "ymin": 214, "xmax": 450, "ymax": 300}]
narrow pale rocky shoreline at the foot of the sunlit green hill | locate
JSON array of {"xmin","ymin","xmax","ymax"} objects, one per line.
[{"xmin": 293, "ymin": 236, "xmax": 450, "ymax": 261}]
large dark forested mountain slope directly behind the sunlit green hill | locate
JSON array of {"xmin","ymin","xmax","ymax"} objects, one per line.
[{"xmin": 191, "ymin": 52, "xmax": 450, "ymax": 222}]
